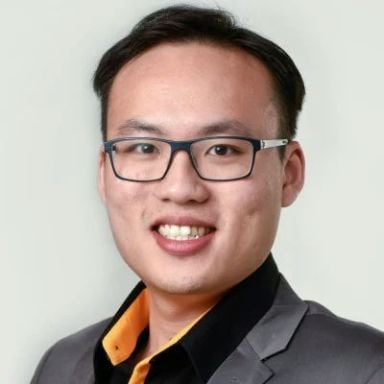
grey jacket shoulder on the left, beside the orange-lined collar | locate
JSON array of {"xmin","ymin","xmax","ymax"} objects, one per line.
[{"xmin": 31, "ymin": 319, "xmax": 110, "ymax": 384}]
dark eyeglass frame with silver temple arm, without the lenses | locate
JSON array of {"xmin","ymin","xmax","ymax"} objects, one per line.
[{"xmin": 103, "ymin": 136, "xmax": 289, "ymax": 183}]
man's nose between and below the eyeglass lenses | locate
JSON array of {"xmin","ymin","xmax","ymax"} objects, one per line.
[{"xmin": 155, "ymin": 151, "xmax": 210, "ymax": 205}]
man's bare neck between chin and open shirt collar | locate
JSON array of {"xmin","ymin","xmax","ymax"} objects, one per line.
[{"xmin": 141, "ymin": 288, "xmax": 222, "ymax": 357}]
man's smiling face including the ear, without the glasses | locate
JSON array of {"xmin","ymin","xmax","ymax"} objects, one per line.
[{"xmin": 99, "ymin": 43, "xmax": 304, "ymax": 295}]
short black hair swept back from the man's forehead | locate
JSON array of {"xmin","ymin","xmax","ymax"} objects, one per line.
[{"xmin": 93, "ymin": 5, "xmax": 305, "ymax": 140}]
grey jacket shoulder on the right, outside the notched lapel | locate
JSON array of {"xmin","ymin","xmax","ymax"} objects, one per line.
[{"xmin": 270, "ymin": 302, "xmax": 384, "ymax": 383}]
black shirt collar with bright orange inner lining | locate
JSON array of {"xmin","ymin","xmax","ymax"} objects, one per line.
[{"xmin": 94, "ymin": 255, "xmax": 279, "ymax": 382}]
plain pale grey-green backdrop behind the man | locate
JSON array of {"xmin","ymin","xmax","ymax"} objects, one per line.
[{"xmin": 0, "ymin": 0, "xmax": 384, "ymax": 384}]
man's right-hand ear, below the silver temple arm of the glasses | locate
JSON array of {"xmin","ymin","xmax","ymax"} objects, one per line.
[{"xmin": 281, "ymin": 141, "xmax": 305, "ymax": 207}]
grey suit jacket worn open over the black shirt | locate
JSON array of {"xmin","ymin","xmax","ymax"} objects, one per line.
[{"xmin": 31, "ymin": 278, "xmax": 384, "ymax": 384}]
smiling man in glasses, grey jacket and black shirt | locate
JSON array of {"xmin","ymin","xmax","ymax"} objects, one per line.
[{"xmin": 32, "ymin": 6, "xmax": 384, "ymax": 384}]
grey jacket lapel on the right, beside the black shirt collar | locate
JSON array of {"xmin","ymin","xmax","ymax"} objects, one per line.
[{"xmin": 208, "ymin": 277, "xmax": 308, "ymax": 384}]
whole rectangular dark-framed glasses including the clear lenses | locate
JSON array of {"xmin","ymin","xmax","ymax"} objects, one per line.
[{"xmin": 104, "ymin": 136, "xmax": 288, "ymax": 182}]
